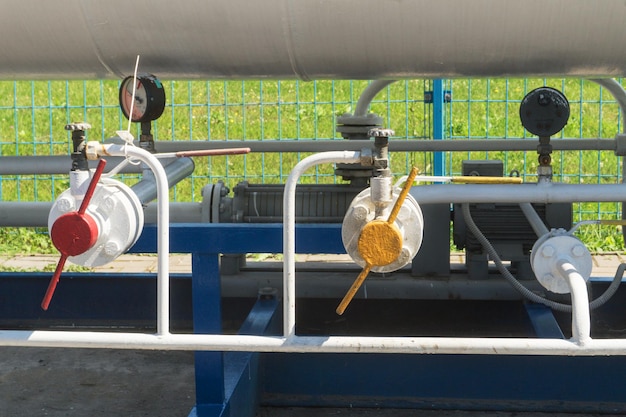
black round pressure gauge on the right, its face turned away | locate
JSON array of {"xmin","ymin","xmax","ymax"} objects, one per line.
[{"xmin": 519, "ymin": 87, "xmax": 569, "ymax": 137}]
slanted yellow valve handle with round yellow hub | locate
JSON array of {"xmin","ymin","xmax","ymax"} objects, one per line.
[{"xmin": 335, "ymin": 167, "xmax": 418, "ymax": 315}]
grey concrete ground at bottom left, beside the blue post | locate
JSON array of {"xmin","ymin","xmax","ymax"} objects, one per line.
[{"xmin": 0, "ymin": 347, "xmax": 195, "ymax": 417}]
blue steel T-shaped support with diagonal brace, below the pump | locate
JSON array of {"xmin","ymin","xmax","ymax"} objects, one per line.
[{"xmin": 131, "ymin": 224, "xmax": 344, "ymax": 417}]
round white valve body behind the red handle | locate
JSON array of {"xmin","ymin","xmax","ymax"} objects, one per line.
[{"xmin": 48, "ymin": 171, "xmax": 144, "ymax": 267}]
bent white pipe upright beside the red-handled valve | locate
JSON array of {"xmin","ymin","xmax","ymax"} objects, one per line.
[{"xmin": 96, "ymin": 144, "xmax": 170, "ymax": 335}]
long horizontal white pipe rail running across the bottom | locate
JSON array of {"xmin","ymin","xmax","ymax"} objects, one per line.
[{"xmin": 0, "ymin": 330, "xmax": 626, "ymax": 356}]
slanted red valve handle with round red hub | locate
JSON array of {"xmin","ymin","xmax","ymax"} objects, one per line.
[{"xmin": 41, "ymin": 159, "xmax": 106, "ymax": 310}]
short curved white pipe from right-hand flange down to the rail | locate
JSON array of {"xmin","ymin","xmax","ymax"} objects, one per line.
[{"xmin": 557, "ymin": 258, "xmax": 591, "ymax": 345}]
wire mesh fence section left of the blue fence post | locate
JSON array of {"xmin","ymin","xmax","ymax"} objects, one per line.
[{"xmin": 0, "ymin": 80, "xmax": 432, "ymax": 201}]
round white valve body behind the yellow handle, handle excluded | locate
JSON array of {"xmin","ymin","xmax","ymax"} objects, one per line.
[{"xmin": 341, "ymin": 187, "xmax": 424, "ymax": 273}]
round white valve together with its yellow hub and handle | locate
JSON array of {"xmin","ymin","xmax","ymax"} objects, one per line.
[{"xmin": 336, "ymin": 168, "xmax": 424, "ymax": 315}]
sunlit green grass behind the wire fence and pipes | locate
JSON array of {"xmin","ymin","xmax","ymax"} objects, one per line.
[{"xmin": 0, "ymin": 79, "xmax": 624, "ymax": 253}]
